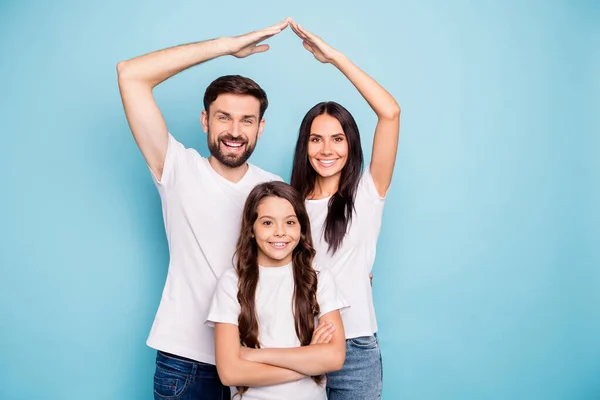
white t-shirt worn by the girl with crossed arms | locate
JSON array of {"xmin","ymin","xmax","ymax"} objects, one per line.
[{"xmin": 207, "ymin": 263, "xmax": 347, "ymax": 400}]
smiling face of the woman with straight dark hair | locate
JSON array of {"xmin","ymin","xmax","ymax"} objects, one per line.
[{"xmin": 308, "ymin": 114, "xmax": 348, "ymax": 178}]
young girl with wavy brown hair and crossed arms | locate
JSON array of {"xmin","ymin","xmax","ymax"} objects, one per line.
[{"xmin": 208, "ymin": 182, "xmax": 345, "ymax": 400}]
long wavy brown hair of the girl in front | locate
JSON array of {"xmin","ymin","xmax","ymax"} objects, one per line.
[{"xmin": 235, "ymin": 181, "xmax": 323, "ymax": 395}]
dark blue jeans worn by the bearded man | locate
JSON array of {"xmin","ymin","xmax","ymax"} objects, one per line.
[{"xmin": 154, "ymin": 351, "xmax": 231, "ymax": 400}]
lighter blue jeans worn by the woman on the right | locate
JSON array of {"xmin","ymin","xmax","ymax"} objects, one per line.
[{"xmin": 327, "ymin": 336, "xmax": 383, "ymax": 400}]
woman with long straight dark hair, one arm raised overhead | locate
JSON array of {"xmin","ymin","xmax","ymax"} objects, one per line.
[{"xmin": 291, "ymin": 22, "xmax": 400, "ymax": 400}]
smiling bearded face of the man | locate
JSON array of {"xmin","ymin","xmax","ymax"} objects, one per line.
[{"xmin": 200, "ymin": 94, "xmax": 265, "ymax": 168}]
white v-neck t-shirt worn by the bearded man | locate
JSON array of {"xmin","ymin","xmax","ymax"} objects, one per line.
[{"xmin": 146, "ymin": 134, "xmax": 282, "ymax": 364}]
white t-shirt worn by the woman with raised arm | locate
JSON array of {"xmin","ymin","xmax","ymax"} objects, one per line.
[{"xmin": 306, "ymin": 168, "xmax": 385, "ymax": 339}]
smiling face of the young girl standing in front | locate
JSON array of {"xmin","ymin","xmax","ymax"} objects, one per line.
[{"xmin": 253, "ymin": 196, "xmax": 300, "ymax": 267}]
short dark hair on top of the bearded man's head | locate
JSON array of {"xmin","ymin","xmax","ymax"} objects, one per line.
[{"xmin": 204, "ymin": 75, "xmax": 269, "ymax": 119}]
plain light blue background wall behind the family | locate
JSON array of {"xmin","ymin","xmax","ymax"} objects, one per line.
[{"xmin": 0, "ymin": 0, "xmax": 600, "ymax": 400}]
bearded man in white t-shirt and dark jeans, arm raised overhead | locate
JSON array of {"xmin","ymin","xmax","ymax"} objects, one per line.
[{"xmin": 117, "ymin": 19, "xmax": 302, "ymax": 399}]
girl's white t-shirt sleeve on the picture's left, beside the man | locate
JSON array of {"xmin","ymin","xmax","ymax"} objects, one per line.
[{"xmin": 206, "ymin": 269, "xmax": 240, "ymax": 327}]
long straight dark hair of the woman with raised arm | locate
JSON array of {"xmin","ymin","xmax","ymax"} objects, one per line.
[{"xmin": 290, "ymin": 101, "xmax": 363, "ymax": 254}]
